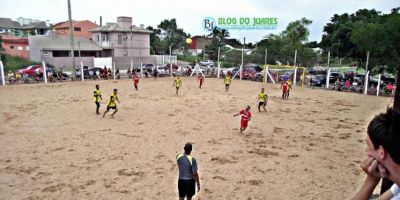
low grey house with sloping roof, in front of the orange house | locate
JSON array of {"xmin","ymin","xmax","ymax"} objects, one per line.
[{"xmin": 28, "ymin": 35, "xmax": 103, "ymax": 67}]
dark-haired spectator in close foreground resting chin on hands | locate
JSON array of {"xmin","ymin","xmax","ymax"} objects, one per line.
[{"xmin": 354, "ymin": 108, "xmax": 400, "ymax": 200}]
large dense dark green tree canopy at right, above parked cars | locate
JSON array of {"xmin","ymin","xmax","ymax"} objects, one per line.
[{"xmin": 319, "ymin": 8, "xmax": 400, "ymax": 72}]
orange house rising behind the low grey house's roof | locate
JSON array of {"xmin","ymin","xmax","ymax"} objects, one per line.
[{"xmin": 53, "ymin": 20, "xmax": 99, "ymax": 39}]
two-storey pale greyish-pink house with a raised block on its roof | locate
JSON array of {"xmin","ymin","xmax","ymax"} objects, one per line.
[{"xmin": 90, "ymin": 17, "xmax": 152, "ymax": 58}]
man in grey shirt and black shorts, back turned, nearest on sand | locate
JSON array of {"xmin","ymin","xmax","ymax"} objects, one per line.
[{"xmin": 176, "ymin": 143, "xmax": 200, "ymax": 200}]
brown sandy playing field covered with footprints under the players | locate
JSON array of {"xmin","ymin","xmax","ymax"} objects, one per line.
[{"xmin": 0, "ymin": 78, "xmax": 391, "ymax": 200}]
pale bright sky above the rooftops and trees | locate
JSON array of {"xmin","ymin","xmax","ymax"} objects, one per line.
[{"xmin": 0, "ymin": 0, "xmax": 400, "ymax": 42}]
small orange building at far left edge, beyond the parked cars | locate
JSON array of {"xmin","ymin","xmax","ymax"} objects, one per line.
[{"xmin": 2, "ymin": 35, "xmax": 29, "ymax": 60}]
